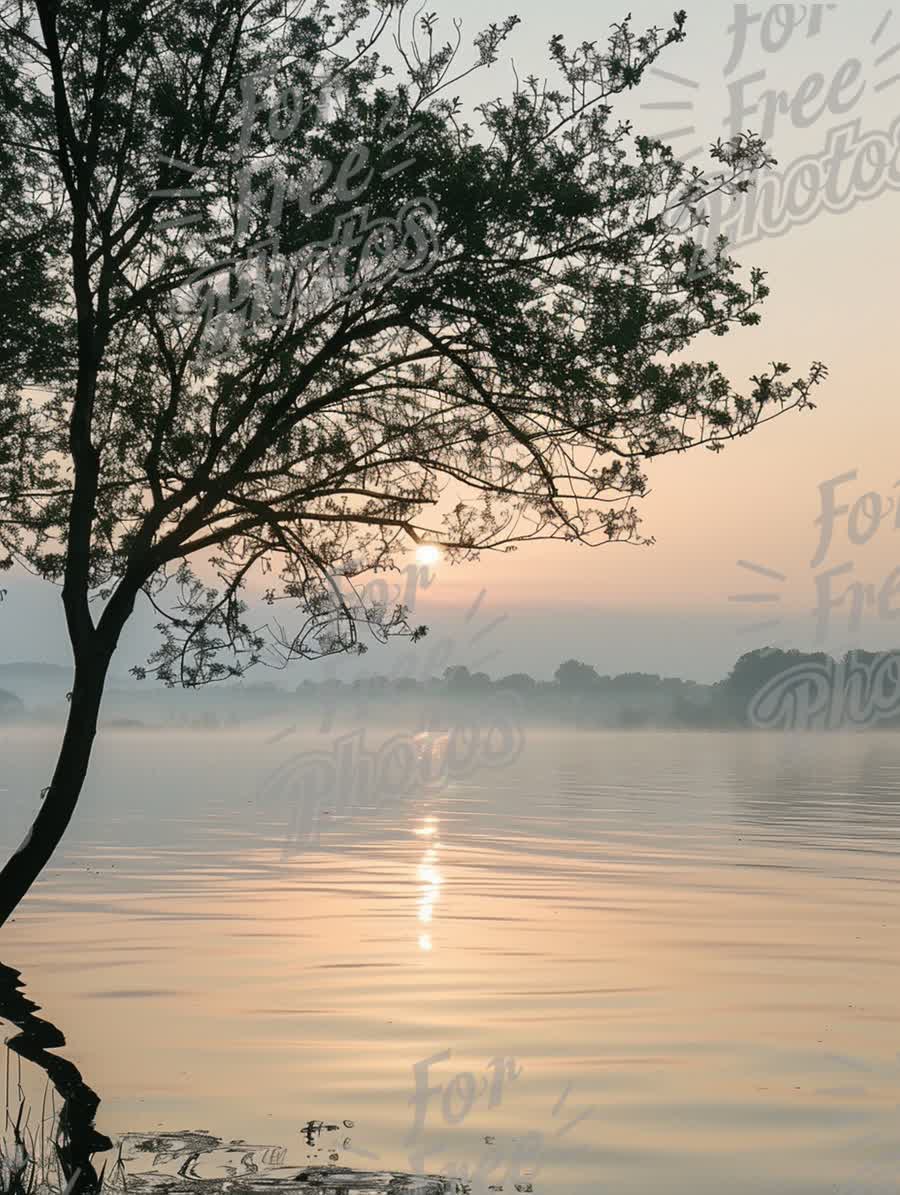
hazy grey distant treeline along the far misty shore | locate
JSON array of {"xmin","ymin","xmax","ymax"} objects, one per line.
[{"xmin": 0, "ymin": 648, "xmax": 900, "ymax": 729}]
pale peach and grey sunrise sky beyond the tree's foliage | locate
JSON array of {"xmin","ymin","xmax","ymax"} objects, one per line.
[{"xmin": 0, "ymin": 0, "xmax": 900, "ymax": 684}]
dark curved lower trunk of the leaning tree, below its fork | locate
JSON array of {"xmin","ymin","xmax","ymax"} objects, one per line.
[{"xmin": 0, "ymin": 649, "xmax": 109, "ymax": 925}]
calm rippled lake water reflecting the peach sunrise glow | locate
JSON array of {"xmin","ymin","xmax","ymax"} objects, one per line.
[{"xmin": 0, "ymin": 729, "xmax": 900, "ymax": 1195}]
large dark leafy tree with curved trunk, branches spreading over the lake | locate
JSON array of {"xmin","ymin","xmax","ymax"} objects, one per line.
[{"xmin": 0, "ymin": 0, "xmax": 824, "ymax": 921}]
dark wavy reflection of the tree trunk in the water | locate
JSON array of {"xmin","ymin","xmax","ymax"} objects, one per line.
[{"xmin": 0, "ymin": 963, "xmax": 112, "ymax": 1195}]
